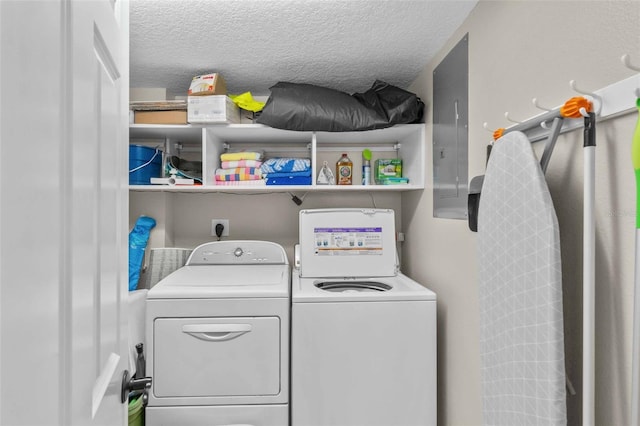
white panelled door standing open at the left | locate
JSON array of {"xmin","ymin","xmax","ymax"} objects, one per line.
[{"xmin": 0, "ymin": 0, "xmax": 129, "ymax": 426}]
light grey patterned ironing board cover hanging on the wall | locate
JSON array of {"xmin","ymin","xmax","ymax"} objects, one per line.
[{"xmin": 478, "ymin": 132, "xmax": 566, "ymax": 426}]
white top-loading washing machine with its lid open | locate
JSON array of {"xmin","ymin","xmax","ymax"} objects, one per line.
[{"xmin": 291, "ymin": 209, "xmax": 437, "ymax": 426}]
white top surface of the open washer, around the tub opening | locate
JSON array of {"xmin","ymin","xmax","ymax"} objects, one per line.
[{"xmin": 291, "ymin": 273, "xmax": 436, "ymax": 303}]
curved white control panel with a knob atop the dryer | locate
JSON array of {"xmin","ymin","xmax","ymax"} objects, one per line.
[{"xmin": 186, "ymin": 241, "xmax": 288, "ymax": 265}]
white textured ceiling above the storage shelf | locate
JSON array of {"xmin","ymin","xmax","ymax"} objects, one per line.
[{"xmin": 130, "ymin": 0, "xmax": 477, "ymax": 96}]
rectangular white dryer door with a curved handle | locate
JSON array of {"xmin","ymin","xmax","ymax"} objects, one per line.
[{"xmin": 153, "ymin": 317, "xmax": 280, "ymax": 398}]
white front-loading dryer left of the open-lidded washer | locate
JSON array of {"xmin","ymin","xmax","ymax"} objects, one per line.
[{"xmin": 145, "ymin": 241, "xmax": 291, "ymax": 426}]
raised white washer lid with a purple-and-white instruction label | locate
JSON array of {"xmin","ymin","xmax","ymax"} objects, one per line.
[{"xmin": 299, "ymin": 208, "xmax": 398, "ymax": 278}]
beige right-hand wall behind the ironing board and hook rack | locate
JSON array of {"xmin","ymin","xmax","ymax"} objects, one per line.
[{"xmin": 402, "ymin": 0, "xmax": 640, "ymax": 425}]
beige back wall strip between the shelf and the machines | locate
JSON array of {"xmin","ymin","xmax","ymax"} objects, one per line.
[{"xmin": 129, "ymin": 191, "xmax": 402, "ymax": 261}]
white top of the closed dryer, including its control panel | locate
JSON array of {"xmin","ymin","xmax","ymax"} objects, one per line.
[{"xmin": 147, "ymin": 241, "xmax": 291, "ymax": 299}]
